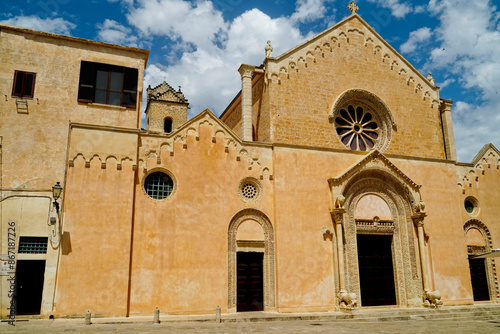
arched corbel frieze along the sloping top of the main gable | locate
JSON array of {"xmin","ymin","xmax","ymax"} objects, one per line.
[{"xmin": 265, "ymin": 14, "xmax": 439, "ymax": 105}]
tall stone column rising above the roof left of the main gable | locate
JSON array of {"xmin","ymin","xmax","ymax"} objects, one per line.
[{"xmin": 238, "ymin": 64, "xmax": 255, "ymax": 141}]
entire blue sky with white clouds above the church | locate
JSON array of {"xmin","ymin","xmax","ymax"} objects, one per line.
[{"xmin": 0, "ymin": 0, "xmax": 500, "ymax": 162}]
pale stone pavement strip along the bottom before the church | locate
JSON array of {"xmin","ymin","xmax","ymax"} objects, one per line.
[{"xmin": 0, "ymin": 319, "xmax": 500, "ymax": 334}]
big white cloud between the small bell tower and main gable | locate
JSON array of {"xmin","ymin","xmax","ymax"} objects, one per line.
[{"xmin": 127, "ymin": 0, "xmax": 325, "ymax": 115}]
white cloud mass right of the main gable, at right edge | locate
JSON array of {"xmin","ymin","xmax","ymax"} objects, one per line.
[{"xmin": 426, "ymin": 0, "xmax": 500, "ymax": 161}]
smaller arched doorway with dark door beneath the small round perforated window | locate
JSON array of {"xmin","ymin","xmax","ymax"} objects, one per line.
[{"xmin": 228, "ymin": 209, "xmax": 276, "ymax": 312}]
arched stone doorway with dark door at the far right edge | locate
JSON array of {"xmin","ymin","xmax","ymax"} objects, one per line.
[{"xmin": 464, "ymin": 219, "xmax": 500, "ymax": 301}]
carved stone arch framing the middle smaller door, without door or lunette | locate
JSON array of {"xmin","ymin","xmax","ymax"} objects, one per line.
[{"xmin": 227, "ymin": 209, "xmax": 276, "ymax": 312}]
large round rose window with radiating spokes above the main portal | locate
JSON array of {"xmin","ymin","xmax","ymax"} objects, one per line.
[{"xmin": 335, "ymin": 105, "xmax": 380, "ymax": 151}]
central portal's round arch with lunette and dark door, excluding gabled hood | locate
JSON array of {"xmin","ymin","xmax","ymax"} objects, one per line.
[{"xmin": 344, "ymin": 170, "xmax": 422, "ymax": 306}]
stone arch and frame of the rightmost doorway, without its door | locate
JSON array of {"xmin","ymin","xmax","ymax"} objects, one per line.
[{"xmin": 464, "ymin": 219, "xmax": 500, "ymax": 301}]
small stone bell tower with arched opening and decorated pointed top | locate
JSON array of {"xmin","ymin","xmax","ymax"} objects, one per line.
[{"xmin": 146, "ymin": 81, "xmax": 189, "ymax": 133}]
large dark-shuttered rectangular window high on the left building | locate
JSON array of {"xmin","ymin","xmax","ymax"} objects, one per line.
[{"xmin": 78, "ymin": 61, "xmax": 138, "ymax": 108}]
